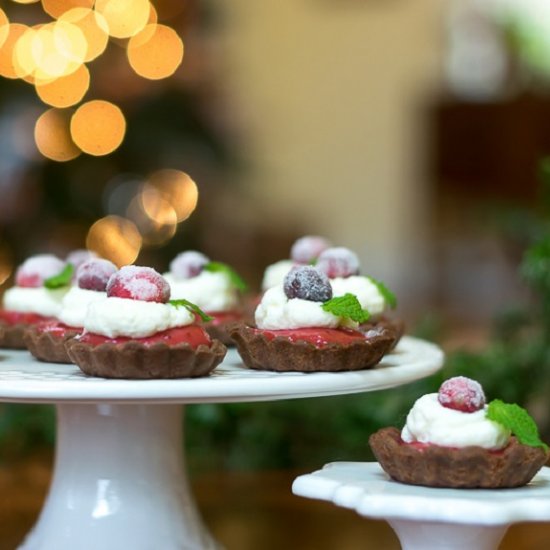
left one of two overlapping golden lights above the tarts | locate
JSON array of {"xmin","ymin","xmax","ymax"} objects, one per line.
[{"xmin": 126, "ymin": 185, "xmax": 178, "ymax": 246}]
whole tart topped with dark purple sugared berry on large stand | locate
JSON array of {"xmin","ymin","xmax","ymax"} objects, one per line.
[{"xmin": 231, "ymin": 266, "xmax": 394, "ymax": 372}]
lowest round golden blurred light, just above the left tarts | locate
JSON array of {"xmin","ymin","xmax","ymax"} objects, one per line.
[{"xmin": 86, "ymin": 216, "xmax": 142, "ymax": 266}]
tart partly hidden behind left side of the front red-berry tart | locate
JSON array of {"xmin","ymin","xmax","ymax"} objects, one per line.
[{"xmin": 25, "ymin": 258, "xmax": 117, "ymax": 363}]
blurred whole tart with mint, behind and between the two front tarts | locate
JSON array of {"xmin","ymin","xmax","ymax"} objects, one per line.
[{"xmin": 164, "ymin": 250, "xmax": 246, "ymax": 345}]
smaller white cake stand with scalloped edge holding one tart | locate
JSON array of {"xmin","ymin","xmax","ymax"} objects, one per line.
[{"xmin": 292, "ymin": 462, "xmax": 550, "ymax": 550}]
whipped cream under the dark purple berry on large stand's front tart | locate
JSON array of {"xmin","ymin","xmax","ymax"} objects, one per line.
[{"xmin": 255, "ymin": 285, "xmax": 349, "ymax": 330}]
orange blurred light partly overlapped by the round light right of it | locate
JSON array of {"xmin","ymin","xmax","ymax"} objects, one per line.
[{"xmin": 34, "ymin": 109, "xmax": 80, "ymax": 162}]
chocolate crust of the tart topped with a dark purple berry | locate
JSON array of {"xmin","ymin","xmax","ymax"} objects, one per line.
[{"xmin": 231, "ymin": 324, "xmax": 394, "ymax": 372}]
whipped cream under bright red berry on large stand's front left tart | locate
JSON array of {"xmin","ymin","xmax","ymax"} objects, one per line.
[{"xmin": 83, "ymin": 297, "xmax": 195, "ymax": 338}]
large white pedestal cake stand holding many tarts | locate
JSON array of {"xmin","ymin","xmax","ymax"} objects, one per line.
[{"xmin": 0, "ymin": 337, "xmax": 443, "ymax": 550}]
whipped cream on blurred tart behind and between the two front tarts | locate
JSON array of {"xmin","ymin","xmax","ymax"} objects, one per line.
[{"xmin": 164, "ymin": 271, "xmax": 238, "ymax": 312}]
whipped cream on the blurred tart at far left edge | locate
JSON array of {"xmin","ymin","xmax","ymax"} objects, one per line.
[{"xmin": 3, "ymin": 286, "xmax": 69, "ymax": 317}]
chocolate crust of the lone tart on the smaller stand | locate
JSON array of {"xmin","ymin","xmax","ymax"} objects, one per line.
[{"xmin": 369, "ymin": 428, "xmax": 549, "ymax": 489}]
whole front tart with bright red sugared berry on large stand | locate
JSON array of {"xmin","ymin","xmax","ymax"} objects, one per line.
[{"xmin": 66, "ymin": 265, "xmax": 227, "ymax": 379}]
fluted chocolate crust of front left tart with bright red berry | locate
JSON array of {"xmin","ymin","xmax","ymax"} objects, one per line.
[{"xmin": 65, "ymin": 338, "xmax": 227, "ymax": 379}]
